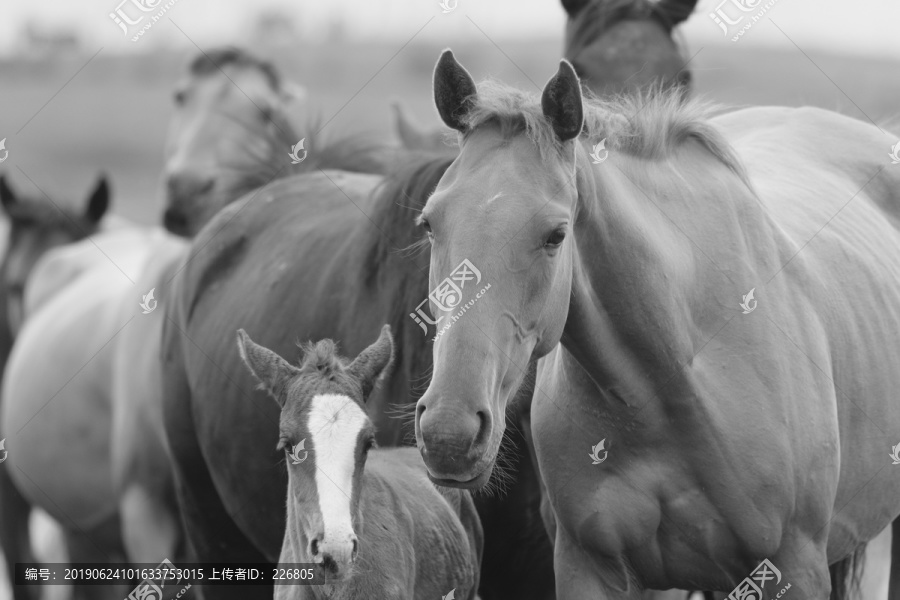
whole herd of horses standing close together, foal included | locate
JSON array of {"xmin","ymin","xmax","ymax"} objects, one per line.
[{"xmin": 0, "ymin": 0, "xmax": 900, "ymax": 600}]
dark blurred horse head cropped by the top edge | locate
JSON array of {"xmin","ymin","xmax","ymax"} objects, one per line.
[{"xmin": 562, "ymin": 0, "xmax": 697, "ymax": 95}]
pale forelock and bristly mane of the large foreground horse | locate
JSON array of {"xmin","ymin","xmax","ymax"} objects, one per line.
[{"xmin": 463, "ymin": 81, "xmax": 749, "ymax": 186}]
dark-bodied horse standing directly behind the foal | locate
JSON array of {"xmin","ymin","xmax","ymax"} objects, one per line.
[{"xmin": 162, "ymin": 156, "xmax": 553, "ymax": 600}]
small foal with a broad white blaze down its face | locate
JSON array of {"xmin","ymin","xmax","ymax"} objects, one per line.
[{"xmin": 238, "ymin": 325, "xmax": 483, "ymax": 600}]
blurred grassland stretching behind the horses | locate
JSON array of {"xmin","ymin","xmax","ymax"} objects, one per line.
[{"xmin": 0, "ymin": 39, "xmax": 900, "ymax": 223}]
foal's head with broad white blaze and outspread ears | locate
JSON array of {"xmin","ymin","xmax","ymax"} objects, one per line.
[{"xmin": 238, "ymin": 325, "xmax": 394, "ymax": 579}]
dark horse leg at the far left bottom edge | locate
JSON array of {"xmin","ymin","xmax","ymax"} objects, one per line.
[{"xmin": 0, "ymin": 468, "xmax": 39, "ymax": 600}]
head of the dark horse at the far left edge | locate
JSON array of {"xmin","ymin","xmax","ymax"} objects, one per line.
[{"xmin": 0, "ymin": 176, "xmax": 109, "ymax": 334}]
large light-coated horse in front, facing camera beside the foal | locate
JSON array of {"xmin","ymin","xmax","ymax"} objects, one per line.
[{"xmin": 415, "ymin": 51, "xmax": 900, "ymax": 600}]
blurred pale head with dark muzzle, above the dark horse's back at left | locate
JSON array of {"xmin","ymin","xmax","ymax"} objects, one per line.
[{"xmin": 163, "ymin": 48, "xmax": 302, "ymax": 237}]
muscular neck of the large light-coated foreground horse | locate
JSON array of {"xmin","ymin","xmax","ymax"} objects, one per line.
[{"xmin": 561, "ymin": 142, "xmax": 768, "ymax": 407}]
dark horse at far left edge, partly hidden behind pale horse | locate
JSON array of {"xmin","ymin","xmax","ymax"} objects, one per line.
[{"xmin": 0, "ymin": 176, "xmax": 110, "ymax": 600}]
